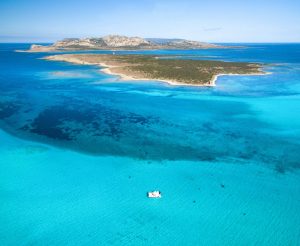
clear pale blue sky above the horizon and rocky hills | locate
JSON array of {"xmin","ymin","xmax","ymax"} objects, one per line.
[{"xmin": 0, "ymin": 0, "xmax": 300, "ymax": 42}]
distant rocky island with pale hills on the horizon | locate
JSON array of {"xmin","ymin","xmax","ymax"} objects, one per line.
[{"xmin": 23, "ymin": 35, "xmax": 229, "ymax": 52}]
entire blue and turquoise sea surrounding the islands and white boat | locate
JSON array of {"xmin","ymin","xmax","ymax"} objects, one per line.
[{"xmin": 0, "ymin": 44, "xmax": 300, "ymax": 246}]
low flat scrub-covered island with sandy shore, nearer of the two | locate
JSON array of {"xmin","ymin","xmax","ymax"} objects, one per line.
[{"xmin": 44, "ymin": 53, "xmax": 266, "ymax": 86}]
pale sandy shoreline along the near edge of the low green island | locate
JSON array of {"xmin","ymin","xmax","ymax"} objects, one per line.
[{"xmin": 43, "ymin": 55, "xmax": 271, "ymax": 87}]
